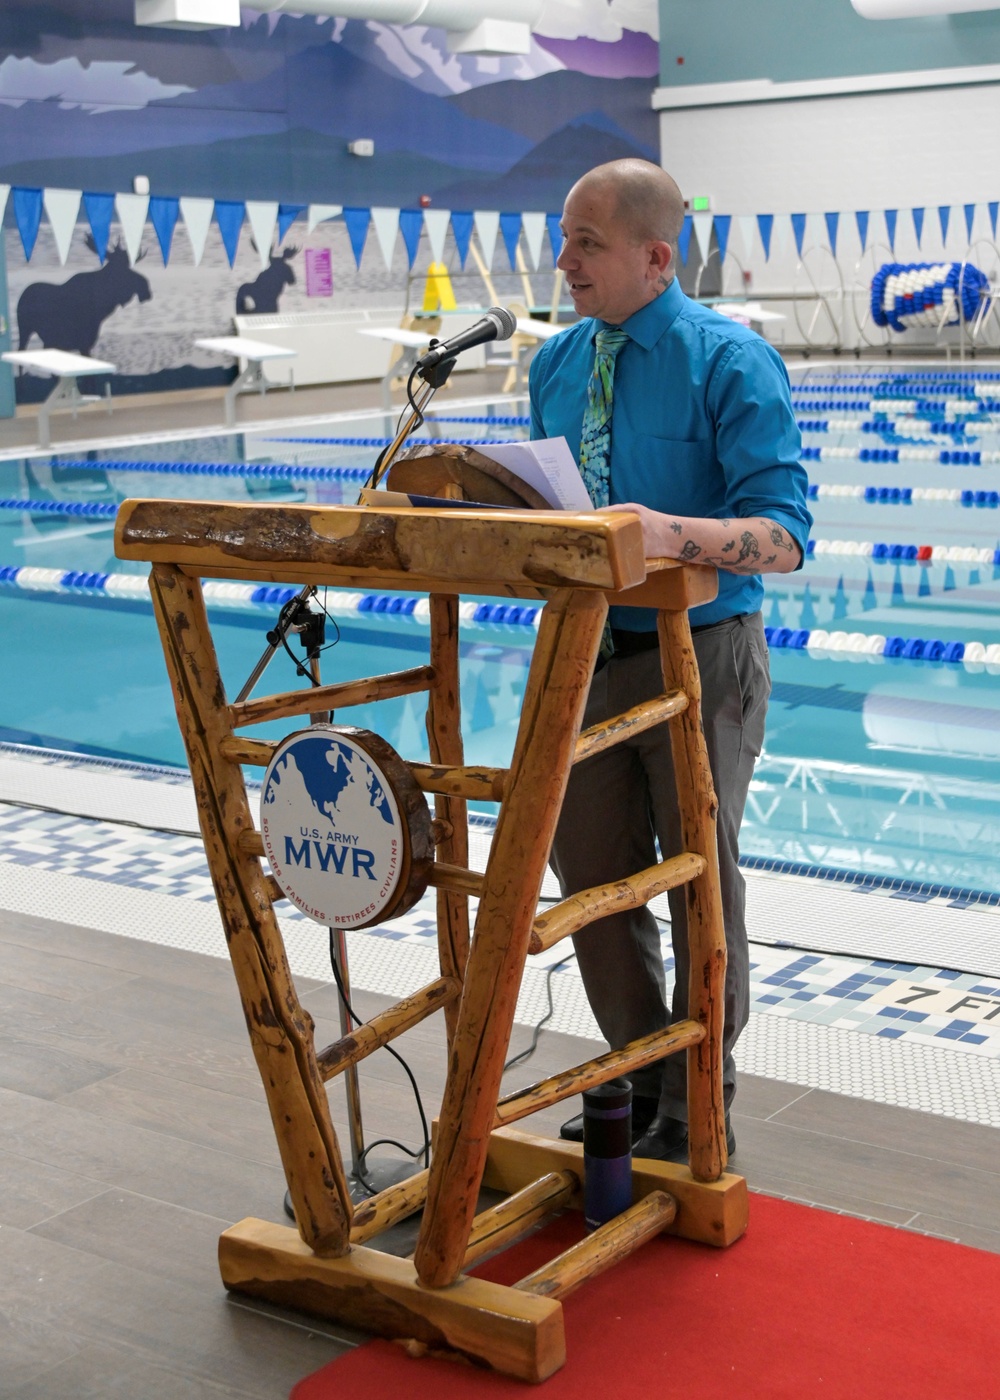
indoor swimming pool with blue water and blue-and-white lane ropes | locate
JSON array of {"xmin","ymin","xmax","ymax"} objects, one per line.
[{"xmin": 0, "ymin": 364, "xmax": 1000, "ymax": 897}]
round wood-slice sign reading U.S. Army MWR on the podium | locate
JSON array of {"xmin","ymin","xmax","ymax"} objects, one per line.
[{"xmin": 261, "ymin": 724, "xmax": 414, "ymax": 928}]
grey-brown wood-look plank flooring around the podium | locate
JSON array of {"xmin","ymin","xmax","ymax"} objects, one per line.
[{"xmin": 0, "ymin": 901, "xmax": 1000, "ymax": 1400}]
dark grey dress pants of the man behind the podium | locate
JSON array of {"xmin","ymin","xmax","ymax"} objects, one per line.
[{"xmin": 550, "ymin": 613, "xmax": 770, "ymax": 1123}]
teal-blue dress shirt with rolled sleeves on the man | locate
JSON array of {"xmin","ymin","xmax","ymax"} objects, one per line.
[{"xmin": 529, "ymin": 281, "xmax": 812, "ymax": 631}]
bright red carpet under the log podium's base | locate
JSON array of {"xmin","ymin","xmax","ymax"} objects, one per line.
[{"xmin": 284, "ymin": 1196, "xmax": 1000, "ymax": 1400}]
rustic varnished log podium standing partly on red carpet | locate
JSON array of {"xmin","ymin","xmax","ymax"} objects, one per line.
[{"xmin": 116, "ymin": 500, "xmax": 746, "ymax": 1380}]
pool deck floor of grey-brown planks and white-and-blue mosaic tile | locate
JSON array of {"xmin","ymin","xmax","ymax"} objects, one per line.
[{"xmin": 0, "ymin": 753, "xmax": 1000, "ymax": 1400}]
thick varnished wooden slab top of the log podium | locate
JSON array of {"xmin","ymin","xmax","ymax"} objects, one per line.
[{"xmin": 115, "ymin": 500, "xmax": 717, "ymax": 608}]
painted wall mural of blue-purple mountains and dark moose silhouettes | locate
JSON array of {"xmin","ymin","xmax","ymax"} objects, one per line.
[{"xmin": 0, "ymin": 0, "xmax": 658, "ymax": 400}]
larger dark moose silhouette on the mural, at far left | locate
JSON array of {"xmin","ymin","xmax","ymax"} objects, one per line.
[{"xmin": 17, "ymin": 234, "xmax": 153, "ymax": 354}]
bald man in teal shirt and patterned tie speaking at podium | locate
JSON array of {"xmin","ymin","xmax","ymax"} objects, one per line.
[{"xmin": 531, "ymin": 160, "xmax": 812, "ymax": 1161}]
